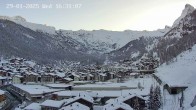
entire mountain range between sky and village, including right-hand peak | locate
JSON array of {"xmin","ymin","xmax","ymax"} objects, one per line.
[{"xmin": 0, "ymin": 4, "xmax": 196, "ymax": 64}]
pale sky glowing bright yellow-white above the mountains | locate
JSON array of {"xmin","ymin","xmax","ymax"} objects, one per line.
[{"xmin": 0, "ymin": 0, "xmax": 196, "ymax": 31}]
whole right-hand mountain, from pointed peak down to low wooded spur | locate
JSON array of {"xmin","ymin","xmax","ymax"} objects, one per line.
[{"xmin": 108, "ymin": 4, "xmax": 196, "ymax": 64}]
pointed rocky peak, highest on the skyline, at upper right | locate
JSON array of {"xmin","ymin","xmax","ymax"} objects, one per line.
[{"xmin": 172, "ymin": 4, "xmax": 195, "ymax": 27}]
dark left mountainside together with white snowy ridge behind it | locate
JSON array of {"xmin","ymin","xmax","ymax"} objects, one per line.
[{"xmin": 0, "ymin": 16, "xmax": 170, "ymax": 64}]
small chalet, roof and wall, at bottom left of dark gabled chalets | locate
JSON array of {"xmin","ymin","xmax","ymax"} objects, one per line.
[{"xmin": 40, "ymin": 100, "xmax": 65, "ymax": 110}]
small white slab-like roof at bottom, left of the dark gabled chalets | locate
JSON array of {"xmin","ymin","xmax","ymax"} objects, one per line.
[{"xmin": 40, "ymin": 100, "xmax": 64, "ymax": 108}]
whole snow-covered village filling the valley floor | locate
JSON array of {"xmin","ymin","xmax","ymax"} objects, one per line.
[{"xmin": 0, "ymin": 57, "xmax": 187, "ymax": 110}]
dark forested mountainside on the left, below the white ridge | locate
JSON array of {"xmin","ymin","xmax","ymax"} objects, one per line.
[{"xmin": 0, "ymin": 19, "xmax": 99, "ymax": 63}]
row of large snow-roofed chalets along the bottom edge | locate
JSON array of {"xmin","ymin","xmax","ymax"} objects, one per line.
[{"xmin": 16, "ymin": 87, "xmax": 147, "ymax": 110}]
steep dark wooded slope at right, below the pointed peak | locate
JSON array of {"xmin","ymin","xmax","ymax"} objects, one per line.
[{"xmin": 152, "ymin": 6, "xmax": 196, "ymax": 63}]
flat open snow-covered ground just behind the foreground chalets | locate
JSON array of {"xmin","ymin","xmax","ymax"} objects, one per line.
[{"xmin": 54, "ymin": 75, "xmax": 157, "ymax": 97}]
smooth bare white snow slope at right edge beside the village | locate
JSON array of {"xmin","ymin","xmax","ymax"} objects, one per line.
[{"xmin": 156, "ymin": 45, "xmax": 196, "ymax": 109}]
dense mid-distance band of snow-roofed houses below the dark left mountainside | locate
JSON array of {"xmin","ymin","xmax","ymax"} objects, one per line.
[{"xmin": 0, "ymin": 58, "xmax": 145, "ymax": 85}]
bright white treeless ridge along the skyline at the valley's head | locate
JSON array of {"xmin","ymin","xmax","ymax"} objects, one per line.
[{"xmin": 0, "ymin": 16, "xmax": 170, "ymax": 53}]
